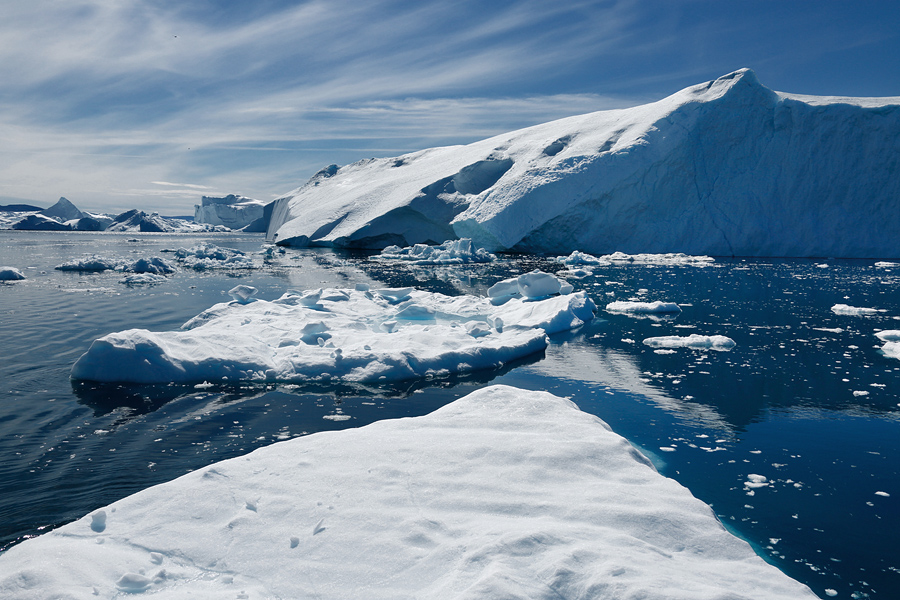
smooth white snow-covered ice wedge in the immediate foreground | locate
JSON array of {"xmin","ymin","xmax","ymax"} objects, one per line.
[{"xmin": 0, "ymin": 386, "xmax": 816, "ymax": 600}]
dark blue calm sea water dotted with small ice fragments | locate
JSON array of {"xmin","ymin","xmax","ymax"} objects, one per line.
[{"xmin": 0, "ymin": 231, "xmax": 900, "ymax": 598}]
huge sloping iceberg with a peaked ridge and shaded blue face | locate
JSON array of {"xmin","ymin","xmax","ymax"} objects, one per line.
[{"xmin": 267, "ymin": 69, "xmax": 900, "ymax": 257}]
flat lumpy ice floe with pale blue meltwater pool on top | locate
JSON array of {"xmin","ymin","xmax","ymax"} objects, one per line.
[{"xmin": 72, "ymin": 286, "xmax": 596, "ymax": 383}]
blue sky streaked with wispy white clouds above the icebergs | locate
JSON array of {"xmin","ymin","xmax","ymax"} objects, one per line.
[{"xmin": 0, "ymin": 0, "xmax": 900, "ymax": 215}]
